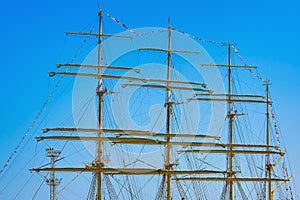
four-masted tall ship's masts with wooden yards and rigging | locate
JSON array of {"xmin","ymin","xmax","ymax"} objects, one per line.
[{"xmin": 0, "ymin": 6, "xmax": 295, "ymax": 200}]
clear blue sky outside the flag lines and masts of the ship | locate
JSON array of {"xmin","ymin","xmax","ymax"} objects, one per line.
[{"xmin": 0, "ymin": 0, "xmax": 300, "ymax": 198}]
